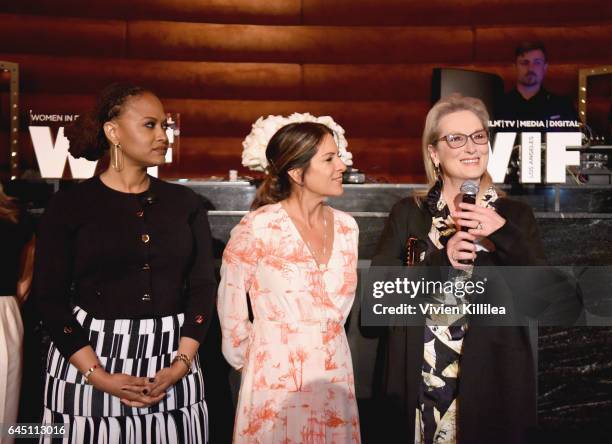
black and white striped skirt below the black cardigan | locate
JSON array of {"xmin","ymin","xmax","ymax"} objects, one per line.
[{"xmin": 41, "ymin": 307, "xmax": 208, "ymax": 444}]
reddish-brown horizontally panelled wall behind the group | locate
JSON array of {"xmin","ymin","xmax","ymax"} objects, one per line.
[{"xmin": 0, "ymin": 0, "xmax": 612, "ymax": 182}]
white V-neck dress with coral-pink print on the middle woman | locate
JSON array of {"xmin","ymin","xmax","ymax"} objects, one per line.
[{"xmin": 217, "ymin": 203, "xmax": 360, "ymax": 444}]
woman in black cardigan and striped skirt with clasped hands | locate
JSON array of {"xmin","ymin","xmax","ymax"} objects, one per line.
[{"xmin": 34, "ymin": 84, "xmax": 216, "ymax": 444}]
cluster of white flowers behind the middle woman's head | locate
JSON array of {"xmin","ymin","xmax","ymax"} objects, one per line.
[{"xmin": 242, "ymin": 113, "xmax": 353, "ymax": 171}]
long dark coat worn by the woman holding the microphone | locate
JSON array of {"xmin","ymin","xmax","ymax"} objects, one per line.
[{"xmin": 364, "ymin": 198, "xmax": 580, "ymax": 444}]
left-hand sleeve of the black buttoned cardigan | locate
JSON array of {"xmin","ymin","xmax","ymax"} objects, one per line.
[{"xmin": 33, "ymin": 192, "xmax": 89, "ymax": 359}]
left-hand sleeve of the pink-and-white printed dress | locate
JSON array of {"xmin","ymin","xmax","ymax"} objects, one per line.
[{"xmin": 217, "ymin": 214, "xmax": 263, "ymax": 369}]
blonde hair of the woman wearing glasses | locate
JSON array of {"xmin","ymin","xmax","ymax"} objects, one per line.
[{"xmin": 415, "ymin": 93, "xmax": 501, "ymax": 198}]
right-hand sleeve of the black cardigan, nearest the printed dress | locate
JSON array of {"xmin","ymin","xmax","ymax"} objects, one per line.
[{"xmin": 181, "ymin": 193, "xmax": 217, "ymax": 343}]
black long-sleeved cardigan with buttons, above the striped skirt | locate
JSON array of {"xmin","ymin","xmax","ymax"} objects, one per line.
[{"xmin": 34, "ymin": 177, "xmax": 216, "ymax": 358}]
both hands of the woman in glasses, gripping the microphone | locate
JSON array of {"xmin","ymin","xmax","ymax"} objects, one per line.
[{"xmin": 446, "ymin": 202, "xmax": 506, "ymax": 269}]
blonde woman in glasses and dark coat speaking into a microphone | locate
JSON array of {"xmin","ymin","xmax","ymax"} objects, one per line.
[{"xmin": 372, "ymin": 95, "xmax": 544, "ymax": 444}]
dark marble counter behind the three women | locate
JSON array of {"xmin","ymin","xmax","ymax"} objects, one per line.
[{"xmin": 187, "ymin": 182, "xmax": 612, "ymax": 434}]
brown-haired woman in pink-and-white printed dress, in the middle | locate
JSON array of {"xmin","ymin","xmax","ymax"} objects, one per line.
[{"xmin": 218, "ymin": 119, "xmax": 360, "ymax": 443}]
